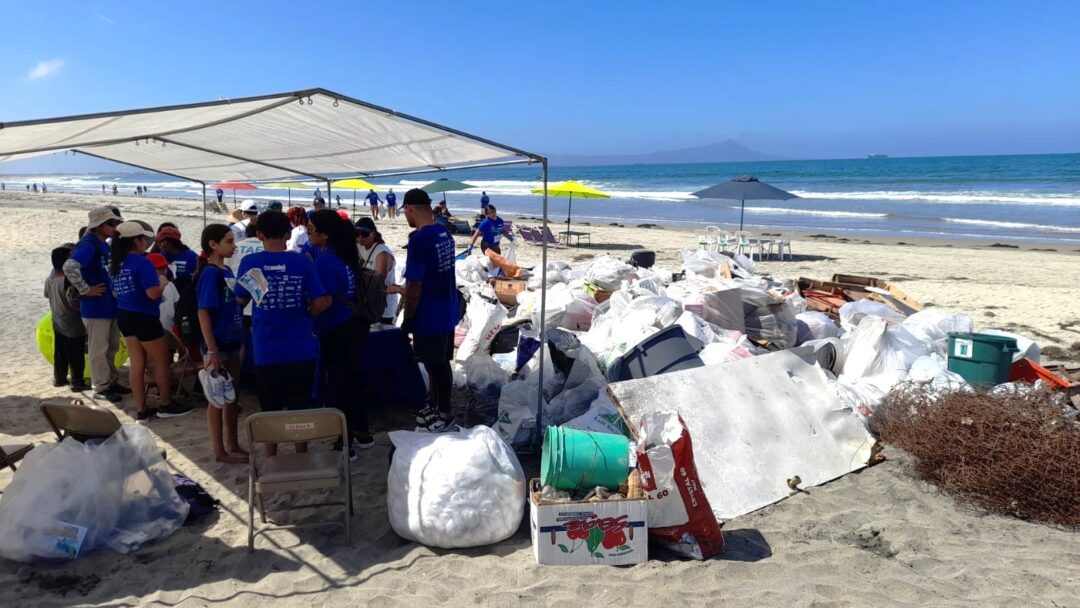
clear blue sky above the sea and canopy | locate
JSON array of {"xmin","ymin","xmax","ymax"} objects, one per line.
[{"xmin": 0, "ymin": 0, "xmax": 1080, "ymax": 158}]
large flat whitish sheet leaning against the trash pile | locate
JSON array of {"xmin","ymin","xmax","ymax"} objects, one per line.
[{"xmin": 608, "ymin": 351, "xmax": 874, "ymax": 519}]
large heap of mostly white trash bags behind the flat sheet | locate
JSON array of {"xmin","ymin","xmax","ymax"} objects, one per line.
[{"xmin": 444, "ymin": 247, "xmax": 1038, "ymax": 447}]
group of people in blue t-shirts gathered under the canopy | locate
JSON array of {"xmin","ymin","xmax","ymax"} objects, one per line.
[{"xmin": 44, "ymin": 189, "xmax": 464, "ymax": 462}]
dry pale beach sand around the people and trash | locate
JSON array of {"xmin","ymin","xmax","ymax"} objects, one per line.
[{"xmin": 0, "ymin": 193, "xmax": 1080, "ymax": 607}]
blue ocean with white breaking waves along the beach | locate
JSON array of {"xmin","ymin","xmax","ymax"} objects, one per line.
[{"xmin": 0, "ymin": 153, "xmax": 1080, "ymax": 245}]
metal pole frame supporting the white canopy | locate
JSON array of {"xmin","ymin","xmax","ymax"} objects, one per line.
[{"xmin": 0, "ymin": 87, "xmax": 549, "ymax": 451}]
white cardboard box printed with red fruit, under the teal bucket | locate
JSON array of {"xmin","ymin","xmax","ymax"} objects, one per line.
[{"xmin": 529, "ymin": 479, "xmax": 649, "ymax": 566}]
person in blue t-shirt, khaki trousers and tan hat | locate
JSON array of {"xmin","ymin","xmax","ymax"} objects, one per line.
[{"xmin": 64, "ymin": 207, "xmax": 131, "ymax": 403}]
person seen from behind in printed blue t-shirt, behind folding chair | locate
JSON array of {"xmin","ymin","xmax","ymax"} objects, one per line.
[{"xmin": 233, "ymin": 211, "xmax": 330, "ymax": 456}]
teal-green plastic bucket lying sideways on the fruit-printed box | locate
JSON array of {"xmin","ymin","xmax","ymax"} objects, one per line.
[{"xmin": 540, "ymin": 427, "xmax": 630, "ymax": 491}]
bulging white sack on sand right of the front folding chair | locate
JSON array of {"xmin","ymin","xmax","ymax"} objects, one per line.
[{"xmin": 387, "ymin": 425, "xmax": 525, "ymax": 549}]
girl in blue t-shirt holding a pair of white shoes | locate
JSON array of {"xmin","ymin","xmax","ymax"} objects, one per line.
[{"xmin": 195, "ymin": 224, "xmax": 247, "ymax": 463}]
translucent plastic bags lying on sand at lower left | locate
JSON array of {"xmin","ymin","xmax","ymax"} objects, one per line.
[{"xmin": 0, "ymin": 424, "xmax": 188, "ymax": 562}]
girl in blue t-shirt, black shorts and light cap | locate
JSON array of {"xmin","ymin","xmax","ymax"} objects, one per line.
[{"xmin": 109, "ymin": 221, "xmax": 191, "ymax": 421}]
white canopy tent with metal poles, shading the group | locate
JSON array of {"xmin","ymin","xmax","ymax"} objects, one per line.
[{"xmin": 0, "ymin": 89, "xmax": 548, "ymax": 447}]
